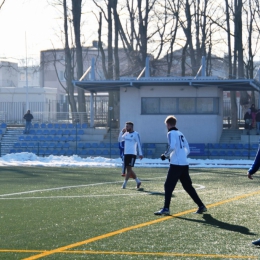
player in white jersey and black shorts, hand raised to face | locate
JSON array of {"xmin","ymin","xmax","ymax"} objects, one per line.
[{"xmin": 118, "ymin": 122, "xmax": 143, "ymax": 189}]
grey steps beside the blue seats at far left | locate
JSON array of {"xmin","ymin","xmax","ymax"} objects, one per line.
[{"xmin": 1, "ymin": 126, "xmax": 24, "ymax": 156}]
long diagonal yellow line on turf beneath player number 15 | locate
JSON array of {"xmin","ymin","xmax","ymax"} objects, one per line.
[{"xmin": 24, "ymin": 191, "xmax": 260, "ymax": 260}]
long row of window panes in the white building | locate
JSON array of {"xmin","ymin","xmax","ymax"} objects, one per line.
[{"xmin": 141, "ymin": 97, "xmax": 219, "ymax": 115}]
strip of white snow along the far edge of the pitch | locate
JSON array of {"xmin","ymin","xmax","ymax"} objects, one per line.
[{"xmin": 0, "ymin": 152, "xmax": 253, "ymax": 170}]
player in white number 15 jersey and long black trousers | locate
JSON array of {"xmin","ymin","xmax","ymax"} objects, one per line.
[{"xmin": 154, "ymin": 116, "xmax": 207, "ymax": 215}]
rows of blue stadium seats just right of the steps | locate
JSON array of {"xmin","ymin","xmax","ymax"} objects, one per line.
[{"xmin": 7, "ymin": 124, "xmax": 155, "ymax": 158}]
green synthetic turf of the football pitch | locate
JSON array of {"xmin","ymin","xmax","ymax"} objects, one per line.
[{"xmin": 0, "ymin": 167, "xmax": 260, "ymax": 260}]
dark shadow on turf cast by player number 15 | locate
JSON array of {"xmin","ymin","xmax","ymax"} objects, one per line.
[{"xmin": 176, "ymin": 214, "xmax": 256, "ymax": 236}]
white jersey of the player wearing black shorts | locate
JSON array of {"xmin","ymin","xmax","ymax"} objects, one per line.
[{"xmin": 118, "ymin": 131, "xmax": 143, "ymax": 155}]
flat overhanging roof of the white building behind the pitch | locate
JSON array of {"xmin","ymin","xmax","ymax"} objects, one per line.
[{"xmin": 73, "ymin": 77, "xmax": 260, "ymax": 93}]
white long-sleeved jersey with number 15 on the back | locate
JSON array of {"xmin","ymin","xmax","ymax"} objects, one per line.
[{"xmin": 164, "ymin": 127, "xmax": 190, "ymax": 165}]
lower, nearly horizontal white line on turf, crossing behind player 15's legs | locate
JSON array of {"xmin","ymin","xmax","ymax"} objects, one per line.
[{"xmin": 0, "ymin": 184, "xmax": 205, "ymax": 200}]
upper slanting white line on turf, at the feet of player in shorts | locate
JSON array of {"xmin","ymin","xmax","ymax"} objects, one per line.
[{"xmin": 0, "ymin": 172, "xmax": 204, "ymax": 199}]
